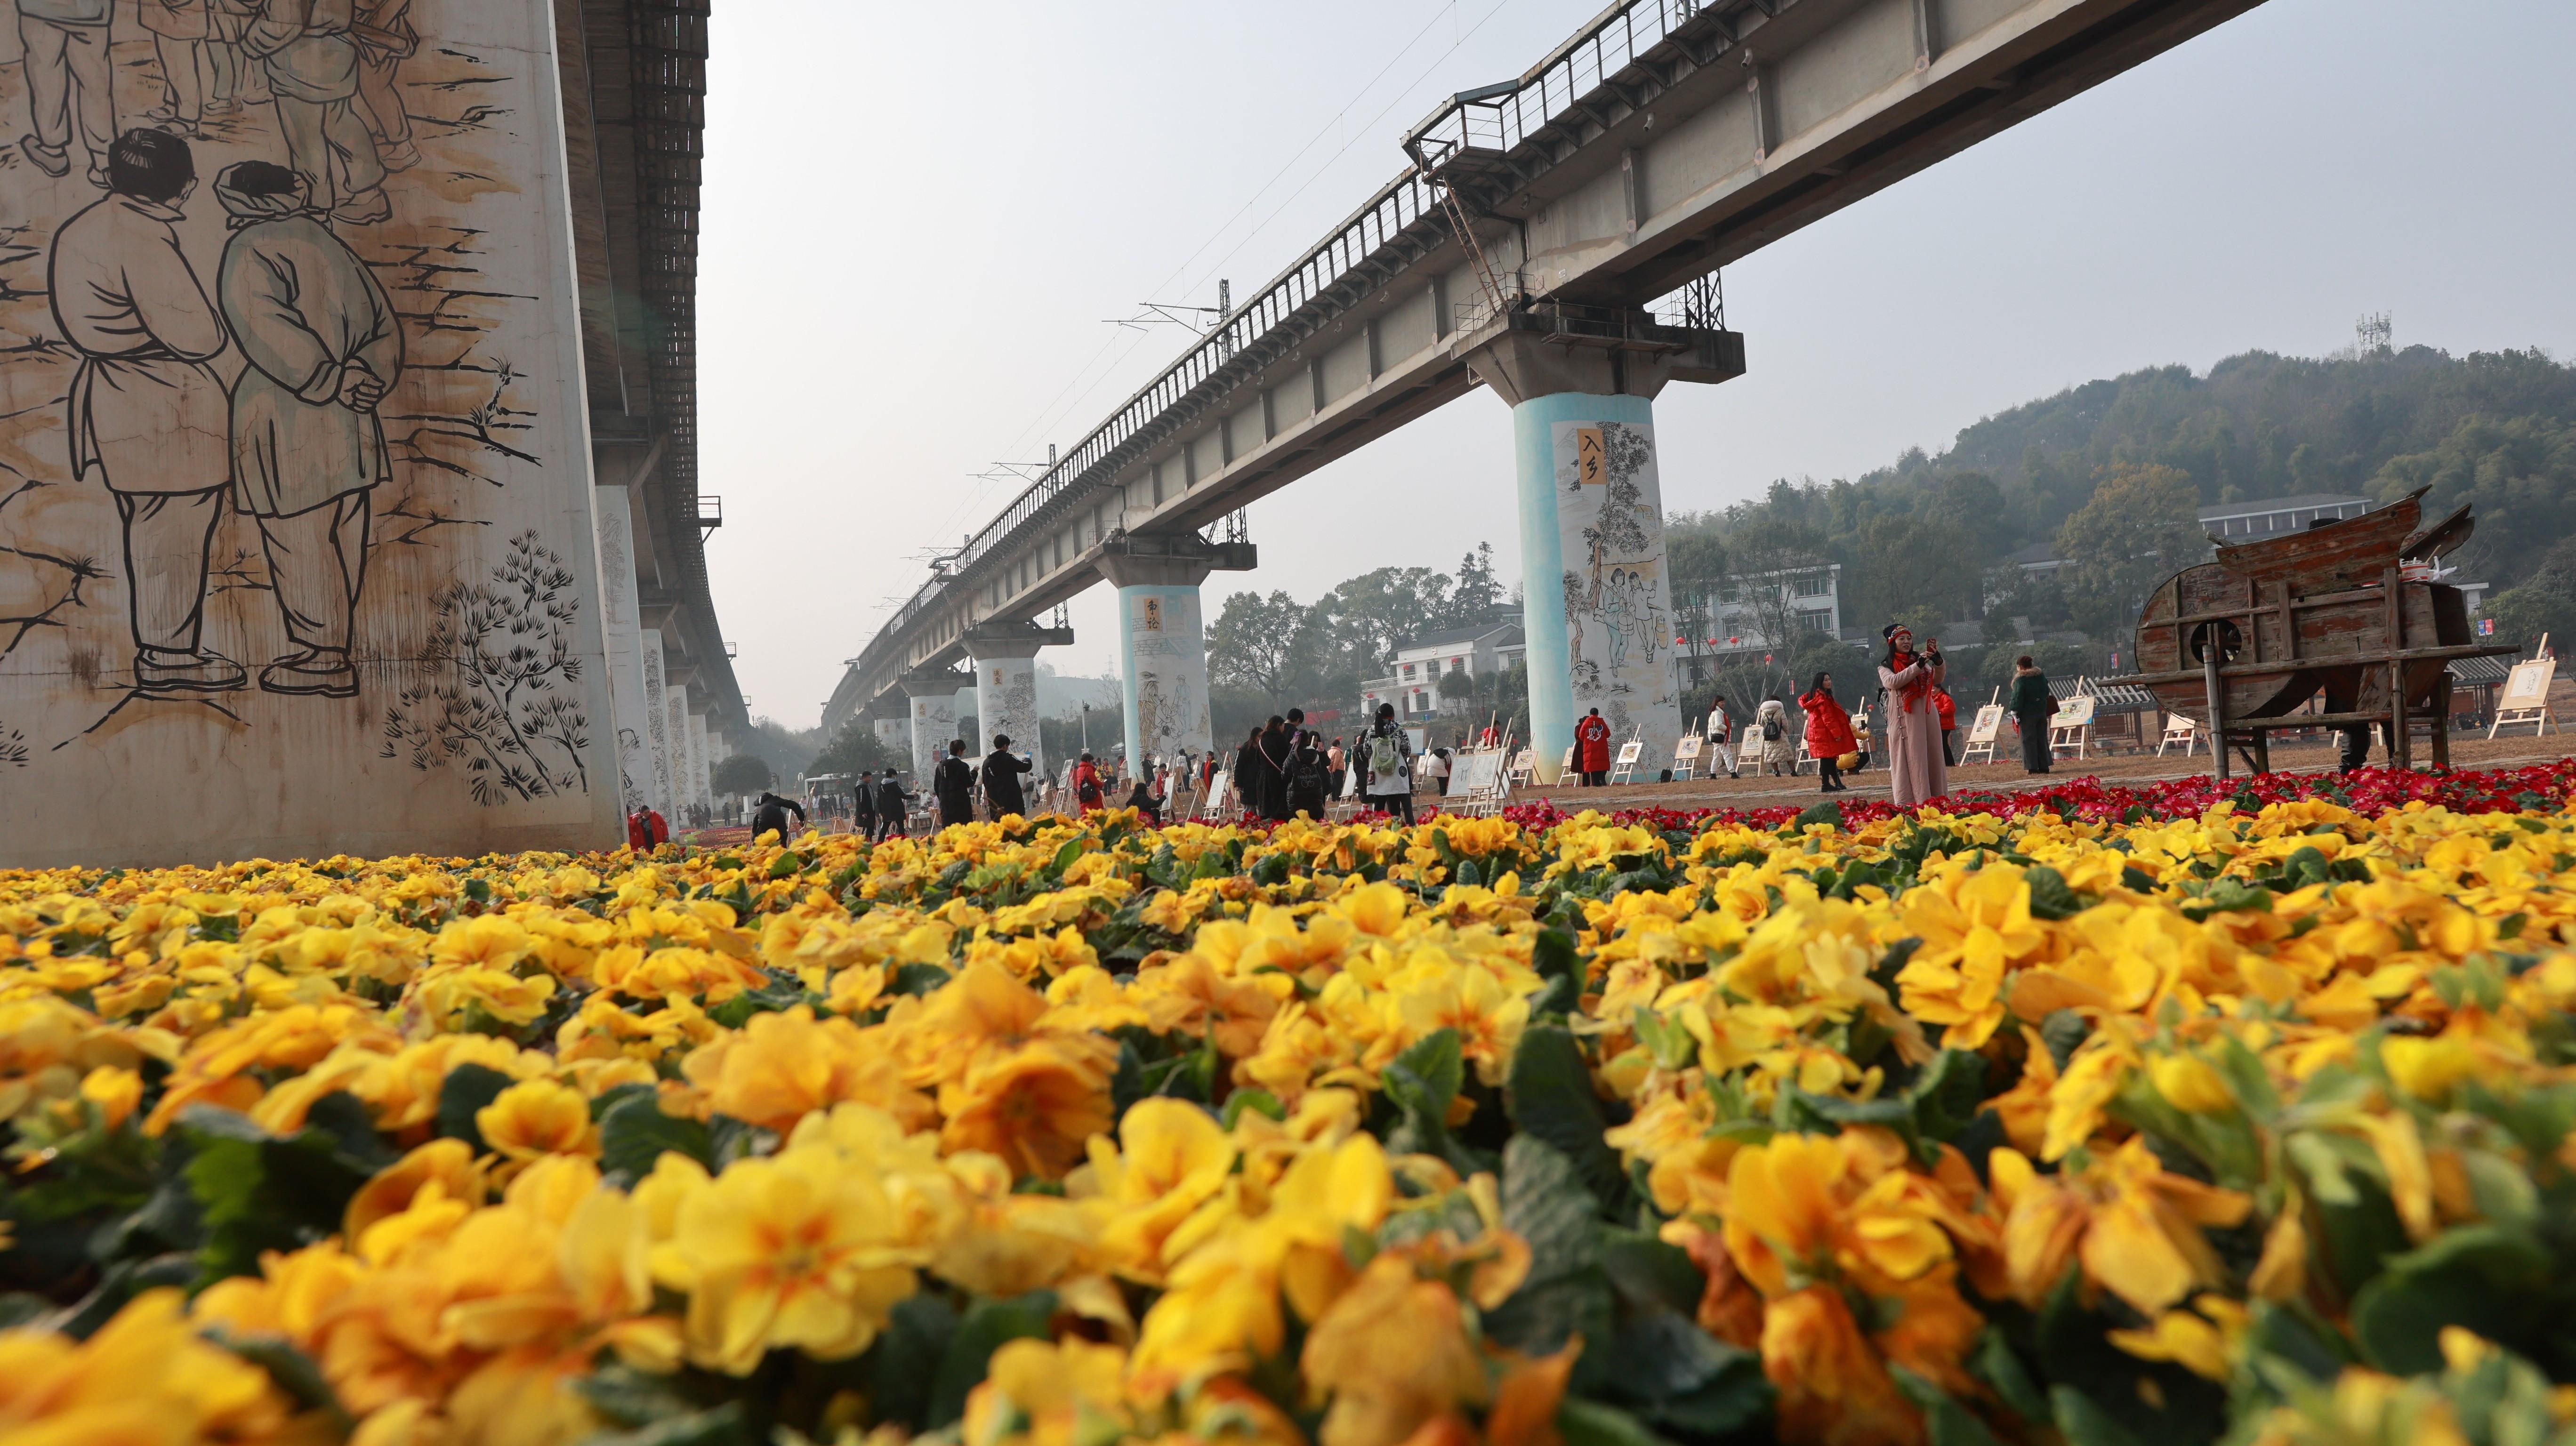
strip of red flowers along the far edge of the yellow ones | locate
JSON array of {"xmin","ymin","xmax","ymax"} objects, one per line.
[{"xmin": 1502, "ymin": 758, "xmax": 2576, "ymax": 833}]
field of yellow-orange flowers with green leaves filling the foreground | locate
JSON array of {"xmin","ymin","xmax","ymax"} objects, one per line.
[{"xmin": 0, "ymin": 779, "xmax": 2576, "ymax": 1446}]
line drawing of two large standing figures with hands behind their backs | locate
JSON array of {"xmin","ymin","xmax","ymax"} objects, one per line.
[{"xmin": 46, "ymin": 129, "xmax": 402, "ymax": 699}]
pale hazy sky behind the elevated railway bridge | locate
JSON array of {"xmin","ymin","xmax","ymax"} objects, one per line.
[{"xmin": 698, "ymin": 0, "xmax": 2576, "ymax": 727}]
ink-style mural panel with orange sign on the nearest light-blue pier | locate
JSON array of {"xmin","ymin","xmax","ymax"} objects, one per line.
[{"xmin": 1554, "ymin": 420, "xmax": 1682, "ymax": 768}]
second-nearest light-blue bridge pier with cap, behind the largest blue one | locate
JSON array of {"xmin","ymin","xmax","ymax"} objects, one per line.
[{"xmin": 1100, "ymin": 534, "xmax": 1257, "ymax": 771}]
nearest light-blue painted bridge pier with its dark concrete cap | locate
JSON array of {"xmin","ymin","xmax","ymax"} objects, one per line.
[{"xmin": 1463, "ymin": 322, "xmax": 1744, "ymax": 784}]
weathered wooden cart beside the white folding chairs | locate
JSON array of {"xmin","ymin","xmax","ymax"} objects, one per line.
[{"xmin": 2135, "ymin": 490, "xmax": 2517, "ymax": 779}]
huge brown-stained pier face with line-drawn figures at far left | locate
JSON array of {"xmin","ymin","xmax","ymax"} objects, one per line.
[{"xmin": 0, "ymin": 0, "xmax": 618, "ymax": 866}]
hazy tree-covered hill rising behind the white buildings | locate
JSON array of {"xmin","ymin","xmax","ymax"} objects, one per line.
[{"xmin": 1674, "ymin": 345, "xmax": 2576, "ymax": 639}]
